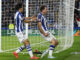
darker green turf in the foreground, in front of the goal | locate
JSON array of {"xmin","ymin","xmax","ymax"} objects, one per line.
[{"xmin": 0, "ymin": 37, "xmax": 80, "ymax": 60}]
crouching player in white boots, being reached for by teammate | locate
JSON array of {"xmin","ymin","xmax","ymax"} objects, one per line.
[{"xmin": 37, "ymin": 5, "xmax": 58, "ymax": 58}]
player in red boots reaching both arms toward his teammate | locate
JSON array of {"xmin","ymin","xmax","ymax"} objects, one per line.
[{"xmin": 13, "ymin": 3, "xmax": 39, "ymax": 59}]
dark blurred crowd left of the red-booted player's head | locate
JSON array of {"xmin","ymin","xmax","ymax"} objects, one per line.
[{"xmin": 2, "ymin": 0, "xmax": 24, "ymax": 27}]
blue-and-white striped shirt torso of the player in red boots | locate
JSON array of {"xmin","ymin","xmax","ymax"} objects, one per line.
[{"xmin": 14, "ymin": 11, "xmax": 23, "ymax": 32}]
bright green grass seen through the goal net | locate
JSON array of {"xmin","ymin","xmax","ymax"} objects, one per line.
[{"xmin": 1, "ymin": 35, "xmax": 65, "ymax": 52}]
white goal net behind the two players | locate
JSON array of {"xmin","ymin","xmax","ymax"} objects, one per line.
[{"xmin": 0, "ymin": 0, "xmax": 75, "ymax": 52}]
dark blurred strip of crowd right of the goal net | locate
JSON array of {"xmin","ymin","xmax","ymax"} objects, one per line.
[{"xmin": 74, "ymin": 0, "xmax": 80, "ymax": 27}]
